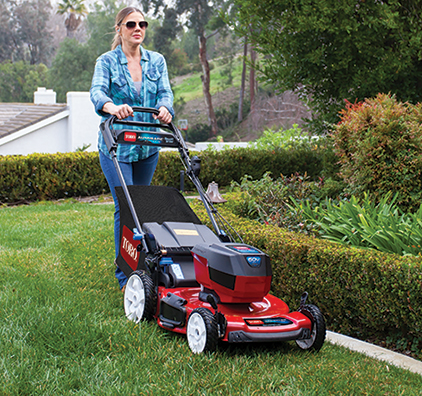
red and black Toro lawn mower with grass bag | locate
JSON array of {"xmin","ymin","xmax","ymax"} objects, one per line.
[{"xmin": 100, "ymin": 107, "xmax": 326, "ymax": 353}]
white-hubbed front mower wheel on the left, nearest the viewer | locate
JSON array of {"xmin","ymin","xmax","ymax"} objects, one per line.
[{"xmin": 186, "ymin": 308, "xmax": 218, "ymax": 353}]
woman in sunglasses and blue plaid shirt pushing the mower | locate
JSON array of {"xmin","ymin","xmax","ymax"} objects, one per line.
[{"xmin": 90, "ymin": 7, "xmax": 174, "ymax": 290}]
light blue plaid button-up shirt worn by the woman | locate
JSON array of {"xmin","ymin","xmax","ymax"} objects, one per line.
[{"xmin": 90, "ymin": 45, "xmax": 174, "ymax": 162}]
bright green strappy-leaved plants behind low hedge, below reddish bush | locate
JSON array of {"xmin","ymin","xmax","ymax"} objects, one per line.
[{"xmin": 294, "ymin": 193, "xmax": 422, "ymax": 256}]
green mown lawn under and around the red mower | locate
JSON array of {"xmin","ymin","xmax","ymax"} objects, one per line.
[{"xmin": 0, "ymin": 201, "xmax": 422, "ymax": 396}]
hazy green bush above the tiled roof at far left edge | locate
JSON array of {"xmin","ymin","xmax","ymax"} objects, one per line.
[{"xmin": 0, "ymin": 61, "xmax": 48, "ymax": 103}]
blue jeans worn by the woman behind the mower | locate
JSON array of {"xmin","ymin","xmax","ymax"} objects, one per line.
[{"xmin": 100, "ymin": 151, "xmax": 158, "ymax": 289}]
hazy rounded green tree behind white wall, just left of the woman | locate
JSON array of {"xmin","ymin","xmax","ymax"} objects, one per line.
[{"xmin": 49, "ymin": 38, "xmax": 97, "ymax": 103}]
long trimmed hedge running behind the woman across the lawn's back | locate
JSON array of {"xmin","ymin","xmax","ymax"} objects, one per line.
[{"xmin": 0, "ymin": 148, "xmax": 332, "ymax": 204}]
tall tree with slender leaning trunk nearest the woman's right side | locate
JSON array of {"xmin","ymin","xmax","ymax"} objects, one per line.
[{"xmin": 142, "ymin": 0, "xmax": 226, "ymax": 136}]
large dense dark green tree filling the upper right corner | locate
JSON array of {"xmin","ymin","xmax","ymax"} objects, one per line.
[{"xmin": 233, "ymin": 0, "xmax": 422, "ymax": 133}]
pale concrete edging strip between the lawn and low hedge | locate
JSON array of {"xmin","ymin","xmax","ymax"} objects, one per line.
[{"xmin": 326, "ymin": 331, "xmax": 422, "ymax": 375}]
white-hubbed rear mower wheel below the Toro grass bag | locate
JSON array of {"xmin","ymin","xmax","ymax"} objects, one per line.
[{"xmin": 123, "ymin": 271, "xmax": 157, "ymax": 323}]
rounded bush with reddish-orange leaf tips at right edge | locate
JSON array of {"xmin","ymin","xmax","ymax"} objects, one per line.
[{"xmin": 332, "ymin": 94, "xmax": 422, "ymax": 210}]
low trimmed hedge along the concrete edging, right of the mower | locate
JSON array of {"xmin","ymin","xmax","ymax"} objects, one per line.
[{"xmin": 192, "ymin": 202, "xmax": 422, "ymax": 355}]
